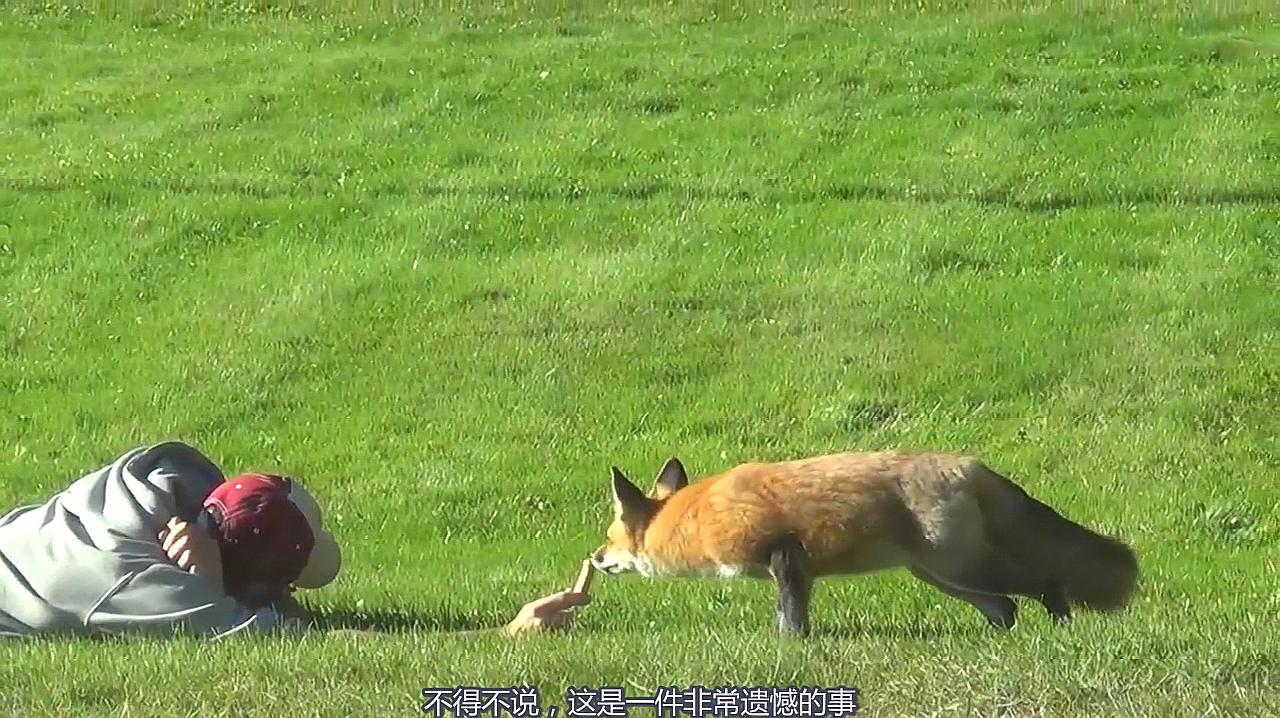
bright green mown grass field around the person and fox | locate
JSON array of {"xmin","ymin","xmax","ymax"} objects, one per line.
[{"xmin": 0, "ymin": 1, "xmax": 1280, "ymax": 718}]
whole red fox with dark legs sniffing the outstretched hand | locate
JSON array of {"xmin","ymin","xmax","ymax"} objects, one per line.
[{"xmin": 591, "ymin": 452, "xmax": 1138, "ymax": 635}]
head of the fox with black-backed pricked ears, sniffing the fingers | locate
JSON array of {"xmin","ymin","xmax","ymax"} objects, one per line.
[{"xmin": 591, "ymin": 457, "xmax": 689, "ymax": 577}]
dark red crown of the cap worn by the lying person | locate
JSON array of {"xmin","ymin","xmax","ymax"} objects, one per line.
[{"xmin": 205, "ymin": 474, "xmax": 315, "ymax": 598}]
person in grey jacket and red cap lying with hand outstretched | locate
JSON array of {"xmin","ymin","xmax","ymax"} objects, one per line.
[{"xmin": 0, "ymin": 442, "xmax": 589, "ymax": 637}]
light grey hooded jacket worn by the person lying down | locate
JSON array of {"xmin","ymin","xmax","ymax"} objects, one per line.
[{"xmin": 0, "ymin": 442, "xmax": 290, "ymax": 637}]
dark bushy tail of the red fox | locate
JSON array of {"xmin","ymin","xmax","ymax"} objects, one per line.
[{"xmin": 975, "ymin": 467, "xmax": 1138, "ymax": 610}]
